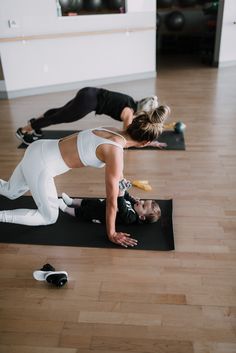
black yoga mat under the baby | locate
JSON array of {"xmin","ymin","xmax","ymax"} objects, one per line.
[{"xmin": 0, "ymin": 196, "xmax": 175, "ymax": 251}]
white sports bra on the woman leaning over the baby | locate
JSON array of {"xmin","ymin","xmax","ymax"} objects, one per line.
[{"xmin": 77, "ymin": 127, "xmax": 126, "ymax": 168}]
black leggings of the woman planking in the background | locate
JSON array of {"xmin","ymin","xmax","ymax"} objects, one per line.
[{"xmin": 31, "ymin": 87, "xmax": 99, "ymax": 130}]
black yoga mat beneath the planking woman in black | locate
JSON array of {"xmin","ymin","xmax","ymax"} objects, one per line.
[{"xmin": 18, "ymin": 130, "xmax": 185, "ymax": 151}]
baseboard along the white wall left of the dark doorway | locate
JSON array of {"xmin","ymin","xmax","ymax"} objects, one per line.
[{"xmin": 0, "ymin": 71, "xmax": 156, "ymax": 99}]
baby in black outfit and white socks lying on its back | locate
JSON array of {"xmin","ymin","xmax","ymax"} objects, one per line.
[{"xmin": 59, "ymin": 184, "xmax": 161, "ymax": 224}]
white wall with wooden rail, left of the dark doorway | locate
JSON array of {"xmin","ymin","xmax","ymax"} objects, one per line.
[{"xmin": 0, "ymin": 0, "xmax": 156, "ymax": 97}]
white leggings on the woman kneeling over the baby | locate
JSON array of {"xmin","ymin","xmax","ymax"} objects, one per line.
[{"xmin": 0, "ymin": 140, "xmax": 70, "ymax": 226}]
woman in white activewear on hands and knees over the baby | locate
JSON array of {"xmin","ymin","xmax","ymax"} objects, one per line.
[{"xmin": 0, "ymin": 106, "xmax": 170, "ymax": 247}]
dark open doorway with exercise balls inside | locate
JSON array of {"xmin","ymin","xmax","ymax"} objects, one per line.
[{"xmin": 156, "ymin": 0, "xmax": 223, "ymax": 69}]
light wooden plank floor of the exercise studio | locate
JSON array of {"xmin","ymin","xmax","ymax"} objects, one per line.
[{"xmin": 0, "ymin": 59, "xmax": 236, "ymax": 353}]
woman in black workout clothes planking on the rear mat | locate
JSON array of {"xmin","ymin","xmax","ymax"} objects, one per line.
[{"xmin": 16, "ymin": 87, "xmax": 166, "ymax": 147}]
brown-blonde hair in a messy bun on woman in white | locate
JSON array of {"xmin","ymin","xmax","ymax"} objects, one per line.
[{"xmin": 126, "ymin": 105, "xmax": 170, "ymax": 142}]
